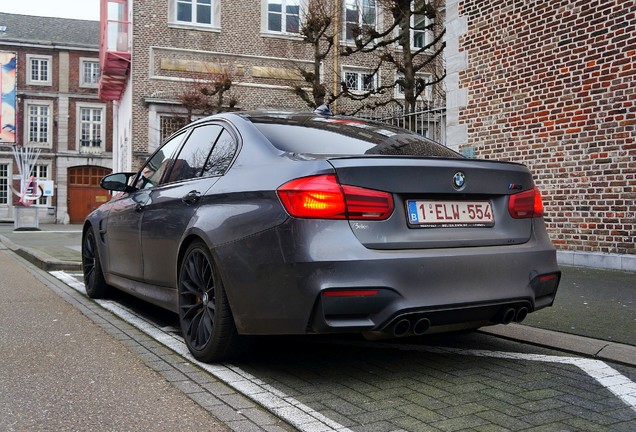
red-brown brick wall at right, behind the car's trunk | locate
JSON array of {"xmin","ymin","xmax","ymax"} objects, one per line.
[{"xmin": 458, "ymin": 0, "xmax": 636, "ymax": 254}]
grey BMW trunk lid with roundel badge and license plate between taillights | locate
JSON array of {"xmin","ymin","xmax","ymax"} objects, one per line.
[{"xmin": 330, "ymin": 156, "xmax": 533, "ymax": 249}]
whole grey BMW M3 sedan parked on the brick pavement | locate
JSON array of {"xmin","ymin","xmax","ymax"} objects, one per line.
[{"xmin": 82, "ymin": 112, "xmax": 561, "ymax": 362}]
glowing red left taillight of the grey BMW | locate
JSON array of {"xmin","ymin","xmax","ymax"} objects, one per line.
[{"xmin": 277, "ymin": 175, "xmax": 393, "ymax": 220}]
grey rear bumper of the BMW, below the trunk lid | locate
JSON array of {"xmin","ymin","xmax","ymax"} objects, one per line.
[{"xmin": 213, "ymin": 220, "xmax": 560, "ymax": 336}]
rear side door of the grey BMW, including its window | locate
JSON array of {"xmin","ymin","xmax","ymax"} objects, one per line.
[{"xmin": 141, "ymin": 123, "xmax": 235, "ymax": 288}]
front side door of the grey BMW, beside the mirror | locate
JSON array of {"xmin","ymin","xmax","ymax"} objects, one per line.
[{"xmin": 106, "ymin": 134, "xmax": 184, "ymax": 281}]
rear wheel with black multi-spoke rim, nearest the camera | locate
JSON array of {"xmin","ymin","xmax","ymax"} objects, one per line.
[{"xmin": 178, "ymin": 241, "xmax": 246, "ymax": 362}]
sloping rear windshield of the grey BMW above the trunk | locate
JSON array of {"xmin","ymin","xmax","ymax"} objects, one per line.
[{"xmin": 249, "ymin": 114, "xmax": 462, "ymax": 158}]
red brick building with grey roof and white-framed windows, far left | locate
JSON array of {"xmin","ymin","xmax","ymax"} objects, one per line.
[{"xmin": 0, "ymin": 13, "xmax": 112, "ymax": 223}]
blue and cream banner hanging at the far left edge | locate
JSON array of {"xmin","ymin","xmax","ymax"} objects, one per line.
[{"xmin": 0, "ymin": 51, "xmax": 17, "ymax": 144}]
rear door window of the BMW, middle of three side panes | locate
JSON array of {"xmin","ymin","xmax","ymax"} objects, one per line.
[{"xmin": 164, "ymin": 125, "xmax": 223, "ymax": 183}]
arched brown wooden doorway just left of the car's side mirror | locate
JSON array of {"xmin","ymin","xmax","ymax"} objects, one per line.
[{"xmin": 68, "ymin": 166, "xmax": 111, "ymax": 223}]
